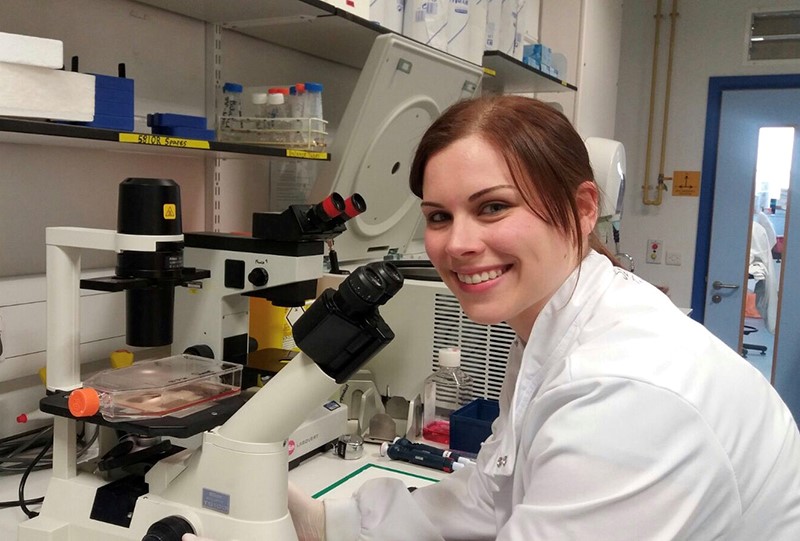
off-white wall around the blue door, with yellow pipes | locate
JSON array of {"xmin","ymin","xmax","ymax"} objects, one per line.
[{"xmin": 615, "ymin": 0, "xmax": 800, "ymax": 307}]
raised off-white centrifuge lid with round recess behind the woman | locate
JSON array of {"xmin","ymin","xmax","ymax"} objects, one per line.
[{"xmin": 306, "ymin": 34, "xmax": 483, "ymax": 262}]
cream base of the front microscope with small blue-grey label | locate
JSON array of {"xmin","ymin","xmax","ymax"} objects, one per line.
[{"xmin": 18, "ymin": 431, "xmax": 297, "ymax": 541}]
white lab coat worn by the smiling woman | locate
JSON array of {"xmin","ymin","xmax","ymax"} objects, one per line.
[{"xmin": 325, "ymin": 252, "xmax": 800, "ymax": 541}]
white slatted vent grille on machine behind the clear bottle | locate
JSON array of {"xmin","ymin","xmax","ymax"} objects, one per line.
[{"xmin": 431, "ymin": 293, "xmax": 515, "ymax": 399}]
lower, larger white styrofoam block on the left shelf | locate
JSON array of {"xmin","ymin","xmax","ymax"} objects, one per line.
[{"xmin": 0, "ymin": 62, "xmax": 94, "ymax": 121}]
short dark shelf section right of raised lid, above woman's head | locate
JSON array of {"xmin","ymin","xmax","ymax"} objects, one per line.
[{"xmin": 482, "ymin": 51, "xmax": 578, "ymax": 94}]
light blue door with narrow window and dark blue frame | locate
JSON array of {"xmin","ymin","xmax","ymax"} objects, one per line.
[{"xmin": 692, "ymin": 77, "xmax": 800, "ymax": 419}]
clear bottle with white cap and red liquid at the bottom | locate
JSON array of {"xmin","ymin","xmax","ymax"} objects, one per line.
[{"xmin": 422, "ymin": 348, "xmax": 472, "ymax": 445}]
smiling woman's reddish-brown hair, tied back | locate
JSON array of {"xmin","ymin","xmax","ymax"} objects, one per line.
[{"xmin": 409, "ymin": 95, "xmax": 619, "ymax": 266}]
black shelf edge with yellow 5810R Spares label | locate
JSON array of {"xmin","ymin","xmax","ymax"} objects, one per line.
[{"xmin": 0, "ymin": 117, "xmax": 330, "ymax": 161}]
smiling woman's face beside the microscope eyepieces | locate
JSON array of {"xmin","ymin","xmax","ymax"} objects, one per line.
[{"xmin": 422, "ymin": 135, "xmax": 596, "ymax": 340}]
